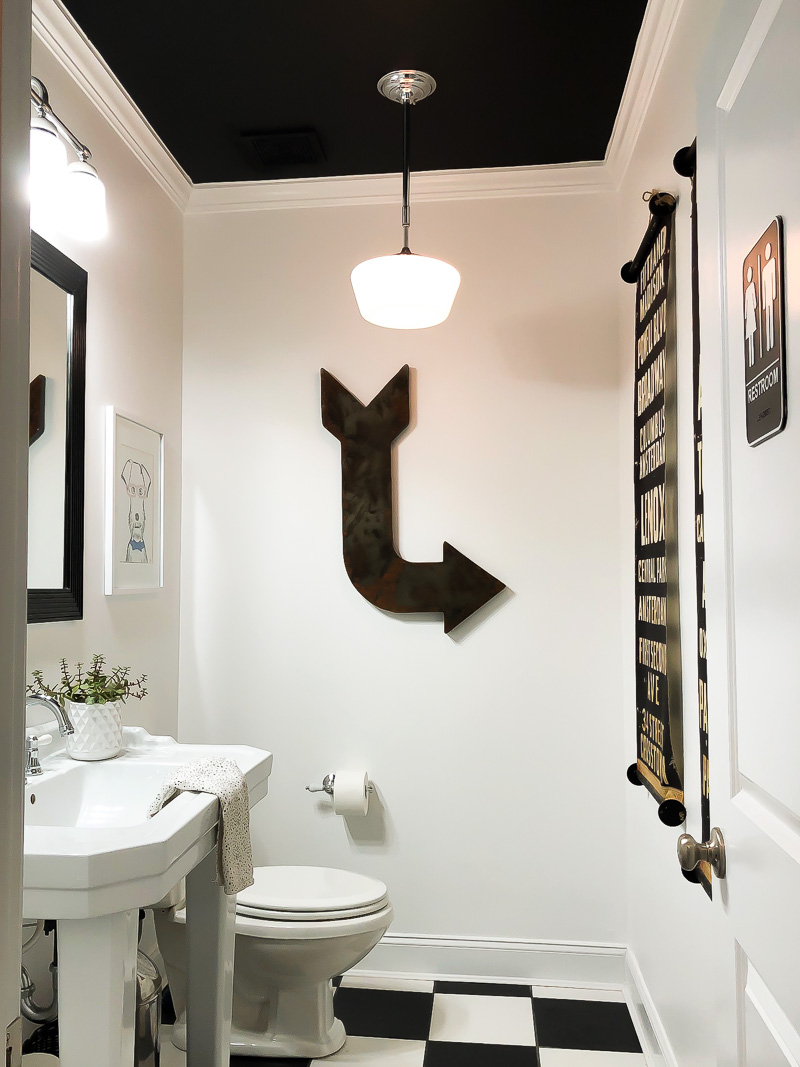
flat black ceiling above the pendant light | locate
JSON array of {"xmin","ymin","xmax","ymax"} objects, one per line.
[{"xmin": 62, "ymin": 0, "xmax": 646, "ymax": 182}]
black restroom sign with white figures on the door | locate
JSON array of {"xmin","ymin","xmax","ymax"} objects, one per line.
[{"xmin": 741, "ymin": 219, "xmax": 786, "ymax": 445}]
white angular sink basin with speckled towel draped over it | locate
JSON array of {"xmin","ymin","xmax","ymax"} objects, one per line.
[{"xmin": 22, "ymin": 727, "xmax": 272, "ymax": 919}]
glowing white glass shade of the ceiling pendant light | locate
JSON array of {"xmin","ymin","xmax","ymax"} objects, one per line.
[{"xmin": 350, "ymin": 252, "xmax": 461, "ymax": 330}]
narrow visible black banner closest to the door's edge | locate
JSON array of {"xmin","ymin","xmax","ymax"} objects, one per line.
[{"xmin": 674, "ymin": 143, "xmax": 711, "ymax": 897}]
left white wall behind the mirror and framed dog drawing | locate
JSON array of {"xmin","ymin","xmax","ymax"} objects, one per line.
[{"xmin": 28, "ymin": 36, "xmax": 182, "ymax": 733}]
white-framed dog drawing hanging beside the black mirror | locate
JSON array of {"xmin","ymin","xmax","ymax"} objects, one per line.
[{"xmin": 106, "ymin": 408, "xmax": 164, "ymax": 596}]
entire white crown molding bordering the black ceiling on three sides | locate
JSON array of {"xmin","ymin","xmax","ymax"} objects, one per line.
[{"xmin": 32, "ymin": 0, "xmax": 685, "ymax": 216}]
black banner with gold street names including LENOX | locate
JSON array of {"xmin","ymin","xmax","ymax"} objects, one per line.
[{"xmin": 622, "ymin": 193, "xmax": 686, "ymax": 826}]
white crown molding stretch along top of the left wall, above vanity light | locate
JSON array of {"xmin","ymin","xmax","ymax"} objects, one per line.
[{"xmin": 32, "ymin": 0, "xmax": 192, "ymax": 211}]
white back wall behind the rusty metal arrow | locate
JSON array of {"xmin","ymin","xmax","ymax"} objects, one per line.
[{"xmin": 180, "ymin": 184, "xmax": 624, "ymax": 941}]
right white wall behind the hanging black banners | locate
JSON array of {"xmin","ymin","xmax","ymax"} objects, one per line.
[{"xmin": 619, "ymin": 0, "xmax": 721, "ymax": 1067}]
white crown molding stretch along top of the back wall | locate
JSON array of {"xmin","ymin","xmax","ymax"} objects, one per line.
[{"xmin": 187, "ymin": 162, "xmax": 611, "ymax": 214}]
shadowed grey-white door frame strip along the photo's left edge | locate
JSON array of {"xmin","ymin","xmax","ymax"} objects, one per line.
[{"xmin": 0, "ymin": 0, "xmax": 31, "ymax": 1067}]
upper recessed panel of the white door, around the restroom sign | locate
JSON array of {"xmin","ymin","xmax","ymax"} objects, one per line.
[{"xmin": 724, "ymin": 2, "xmax": 800, "ymax": 817}]
